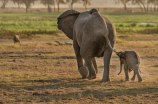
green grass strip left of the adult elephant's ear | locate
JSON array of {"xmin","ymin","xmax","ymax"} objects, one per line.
[{"xmin": 0, "ymin": 13, "xmax": 59, "ymax": 31}]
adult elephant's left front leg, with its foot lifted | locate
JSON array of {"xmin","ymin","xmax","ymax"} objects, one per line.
[{"xmin": 73, "ymin": 40, "xmax": 88, "ymax": 79}]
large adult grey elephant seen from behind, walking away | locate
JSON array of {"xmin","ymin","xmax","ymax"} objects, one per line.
[{"xmin": 57, "ymin": 9, "xmax": 116, "ymax": 81}]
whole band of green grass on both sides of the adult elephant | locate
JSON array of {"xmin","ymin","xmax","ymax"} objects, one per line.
[{"xmin": 0, "ymin": 13, "xmax": 158, "ymax": 34}]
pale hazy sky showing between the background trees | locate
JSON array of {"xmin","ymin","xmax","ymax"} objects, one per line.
[{"xmin": 6, "ymin": 0, "xmax": 136, "ymax": 8}]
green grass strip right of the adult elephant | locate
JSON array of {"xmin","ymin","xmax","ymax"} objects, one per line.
[{"xmin": 103, "ymin": 14, "xmax": 158, "ymax": 31}]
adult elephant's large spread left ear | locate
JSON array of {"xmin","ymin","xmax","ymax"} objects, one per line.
[{"xmin": 57, "ymin": 10, "xmax": 80, "ymax": 39}]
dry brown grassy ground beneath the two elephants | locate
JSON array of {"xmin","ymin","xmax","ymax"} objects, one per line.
[{"xmin": 0, "ymin": 35, "xmax": 158, "ymax": 104}]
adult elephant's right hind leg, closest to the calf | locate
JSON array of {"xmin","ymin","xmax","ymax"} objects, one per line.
[{"xmin": 102, "ymin": 48, "xmax": 112, "ymax": 82}]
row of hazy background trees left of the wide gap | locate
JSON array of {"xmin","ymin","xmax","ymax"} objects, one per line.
[{"xmin": 0, "ymin": 0, "xmax": 92, "ymax": 13}]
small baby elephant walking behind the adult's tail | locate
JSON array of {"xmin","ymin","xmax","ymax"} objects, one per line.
[{"xmin": 117, "ymin": 51, "xmax": 142, "ymax": 82}]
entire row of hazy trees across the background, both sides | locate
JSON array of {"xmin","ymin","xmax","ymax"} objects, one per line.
[{"xmin": 0, "ymin": 0, "xmax": 158, "ymax": 13}]
